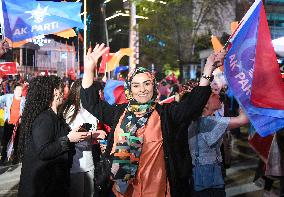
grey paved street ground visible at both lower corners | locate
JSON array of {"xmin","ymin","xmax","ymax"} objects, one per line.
[{"xmin": 0, "ymin": 129, "xmax": 279, "ymax": 197}]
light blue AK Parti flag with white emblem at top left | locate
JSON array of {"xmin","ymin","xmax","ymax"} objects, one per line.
[{"xmin": 2, "ymin": 0, "xmax": 84, "ymax": 42}]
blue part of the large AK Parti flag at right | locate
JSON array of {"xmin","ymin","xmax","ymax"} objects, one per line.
[{"xmin": 224, "ymin": 0, "xmax": 284, "ymax": 137}]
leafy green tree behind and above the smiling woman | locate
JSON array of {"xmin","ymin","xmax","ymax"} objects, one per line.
[{"xmin": 135, "ymin": 0, "xmax": 234, "ymax": 79}]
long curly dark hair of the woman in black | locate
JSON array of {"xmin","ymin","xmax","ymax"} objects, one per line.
[{"xmin": 18, "ymin": 76, "xmax": 63, "ymax": 158}]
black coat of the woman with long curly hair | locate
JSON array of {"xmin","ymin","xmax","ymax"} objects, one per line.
[{"xmin": 18, "ymin": 109, "xmax": 73, "ymax": 197}]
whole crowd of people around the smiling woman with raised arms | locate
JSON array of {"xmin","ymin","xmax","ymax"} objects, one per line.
[{"xmin": 0, "ymin": 38, "xmax": 284, "ymax": 197}]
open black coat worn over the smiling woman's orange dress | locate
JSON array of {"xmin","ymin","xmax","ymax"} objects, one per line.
[{"xmin": 81, "ymin": 82, "xmax": 211, "ymax": 197}]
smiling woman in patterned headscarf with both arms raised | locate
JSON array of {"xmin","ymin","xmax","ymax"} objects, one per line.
[{"xmin": 81, "ymin": 44, "xmax": 225, "ymax": 197}]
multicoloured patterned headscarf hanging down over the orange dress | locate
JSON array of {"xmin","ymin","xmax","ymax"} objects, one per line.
[{"xmin": 112, "ymin": 67, "xmax": 158, "ymax": 194}]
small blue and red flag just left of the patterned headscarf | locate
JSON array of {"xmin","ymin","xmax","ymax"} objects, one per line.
[{"xmin": 104, "ymin": 80, "xmax": 128, "ymax": 105}]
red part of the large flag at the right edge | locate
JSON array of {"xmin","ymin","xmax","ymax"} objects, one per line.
[{"xmin": 251, "ymin": 3, "xmax": 284, "ymax": 109}]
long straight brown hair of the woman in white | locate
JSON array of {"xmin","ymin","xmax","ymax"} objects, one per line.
[{"xmin": 59, "ymin": 79, "xmax": 82, "ymax": 124}]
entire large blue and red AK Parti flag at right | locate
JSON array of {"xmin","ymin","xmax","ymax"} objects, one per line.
[{"xmin": 224, "ymin": 0, "xmax": 284, "ymax": 137}]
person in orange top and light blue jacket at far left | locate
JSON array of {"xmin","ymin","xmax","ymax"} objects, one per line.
[{"xmin": 0, "ymin": 83, "xmax": 25, "ymax": 164}]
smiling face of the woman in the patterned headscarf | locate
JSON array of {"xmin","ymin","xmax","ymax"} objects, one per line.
[{"xmin": 131, "ymin": 73, "xmax": 154, "ymax": 103}]
